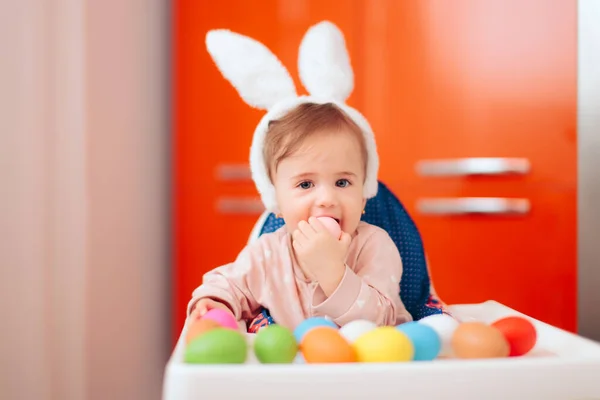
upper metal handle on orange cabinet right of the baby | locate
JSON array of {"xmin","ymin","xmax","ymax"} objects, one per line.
[{"xmin": 416, "ymin": 157, "xmax": 530, "ymax": 176}]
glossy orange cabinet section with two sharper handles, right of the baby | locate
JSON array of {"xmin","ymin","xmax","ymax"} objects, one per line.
[{"xmin": 357, "ymin": 0, "xmax": 577, "ymax": 331}]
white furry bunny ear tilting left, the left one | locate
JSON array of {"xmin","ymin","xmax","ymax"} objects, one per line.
[{"xmin": 206, "ymin": 29, "xmax": 296, "ymax": 110}]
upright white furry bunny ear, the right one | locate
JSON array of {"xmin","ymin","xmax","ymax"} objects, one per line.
[{"xmin": 298, "ymin": 21, "xmax": 354, "ymax": 103}]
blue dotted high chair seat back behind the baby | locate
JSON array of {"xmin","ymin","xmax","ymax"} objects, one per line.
[{"xmin": 253, "ymin": 182, "xmax": 446, "ymax": 320}]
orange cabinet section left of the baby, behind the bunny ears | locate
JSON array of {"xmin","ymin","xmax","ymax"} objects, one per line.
[{"xmin": 172, "ymin": 0, "xmax": 361, "ymax": 337}]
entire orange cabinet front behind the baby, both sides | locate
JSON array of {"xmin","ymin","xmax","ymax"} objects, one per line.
[{"xmin": 173, "ymin": 0, "xmax": 577, "ymax": 333}]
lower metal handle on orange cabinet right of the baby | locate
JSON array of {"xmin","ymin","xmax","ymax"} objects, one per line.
[{"xmin": 417, "ymin": 197, "xmax": 531, "ymax": 215}]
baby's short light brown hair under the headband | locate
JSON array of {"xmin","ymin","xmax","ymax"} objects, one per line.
[{"xmin": 263, "ymin": 103, "xmax": 368, "ymax": 181}]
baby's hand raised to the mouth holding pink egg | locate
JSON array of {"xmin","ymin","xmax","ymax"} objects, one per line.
[{"xmin": 292, "ymin": 217, "xmax": 351, "ymax": 296}]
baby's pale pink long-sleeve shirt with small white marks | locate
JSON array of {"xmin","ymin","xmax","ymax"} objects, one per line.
[{"xmin": 188, "ymin": 222, "xmax": 412, "ymax": 329}]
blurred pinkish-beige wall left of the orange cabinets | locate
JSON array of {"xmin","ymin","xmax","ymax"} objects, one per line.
[{"xmin": 0, "ymin": 0, "xmax": 171, "ymax": 400}]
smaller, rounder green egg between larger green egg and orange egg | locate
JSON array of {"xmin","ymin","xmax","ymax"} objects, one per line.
[{"xmin": 254, "ymin": 324, "xmax": 298, "ymax": 364}]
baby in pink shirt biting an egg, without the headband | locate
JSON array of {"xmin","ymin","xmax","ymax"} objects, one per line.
[{"xmin": 188, "ymin": 102, "xmax": 412, "ymax": 329}]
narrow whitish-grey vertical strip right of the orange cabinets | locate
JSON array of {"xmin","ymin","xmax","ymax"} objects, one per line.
[{"xmin": 577, "ymin": 0, "xmax": 600, "ymax": 341}]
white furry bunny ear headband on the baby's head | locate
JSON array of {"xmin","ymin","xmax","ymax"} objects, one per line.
[{"xmin": 206, "ymin": 21, "xmax": 379, "ymax": 212}]
